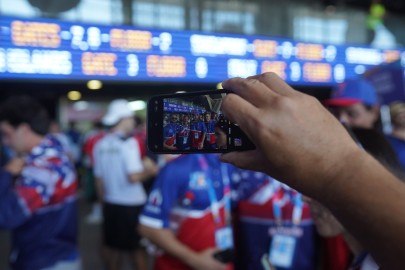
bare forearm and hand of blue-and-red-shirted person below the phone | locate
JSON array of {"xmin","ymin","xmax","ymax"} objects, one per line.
[{"xmin": 139, "ymin": 225, "xmax": 226, "ymax": 270}]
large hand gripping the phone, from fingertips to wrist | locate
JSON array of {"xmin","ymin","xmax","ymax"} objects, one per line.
[{"xmin": 221, "ymin": 73, "xmax": 361, "ymax": 199}]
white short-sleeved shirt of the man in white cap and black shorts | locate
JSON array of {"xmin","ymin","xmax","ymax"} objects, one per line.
[{"xmin": 93, "ymin": 133, "xmax": 146, "ymax": 206}]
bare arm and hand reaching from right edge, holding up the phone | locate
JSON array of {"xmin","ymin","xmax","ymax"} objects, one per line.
[{"xmin": 222, "ymin": 73, "xmax": 405, "ymax": 269}]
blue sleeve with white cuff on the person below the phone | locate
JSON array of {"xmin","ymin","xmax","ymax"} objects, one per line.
[{"xmin": 140, "ymin": 161, "xmax": 188, "ymax": 228}]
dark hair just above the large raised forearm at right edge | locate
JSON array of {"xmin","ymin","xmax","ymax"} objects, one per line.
[{"xmin": 351, "ymin": 128, "xmax": 405, "ymax": 181}]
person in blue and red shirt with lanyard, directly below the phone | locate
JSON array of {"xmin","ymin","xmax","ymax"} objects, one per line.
[{"xmin": 140, "ymin": 154, "xmax": 233, "ymax": 270}]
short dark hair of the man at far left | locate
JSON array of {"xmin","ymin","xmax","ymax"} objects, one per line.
[{"xmin": 0, "ymin": 96, "xmax": 50, "ymax": 135}]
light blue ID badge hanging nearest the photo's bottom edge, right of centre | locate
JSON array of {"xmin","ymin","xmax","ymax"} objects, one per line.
[{"xmin": 269, "ymin": 235, "xmax": 297, "ymax": 268}]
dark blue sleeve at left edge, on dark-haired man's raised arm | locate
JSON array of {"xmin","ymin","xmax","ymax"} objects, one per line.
[{"xmin": 0, "ymin": 169, "xmax": 29, "ymax": 229}]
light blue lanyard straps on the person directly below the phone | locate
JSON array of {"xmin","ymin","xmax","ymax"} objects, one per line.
[{"xmin": 198, "ymin": 155, "xmax": 231, "ymax": 226}]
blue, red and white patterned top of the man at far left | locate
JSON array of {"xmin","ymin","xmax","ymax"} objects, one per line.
[{"xmin": 0, "ymin": 136, "xmax": 78, "ymax": 270}]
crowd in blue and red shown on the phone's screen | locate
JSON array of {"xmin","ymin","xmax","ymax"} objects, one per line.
[{"xmin": 163, "ymin": 111, "xmax": 225, "ymax": 150}]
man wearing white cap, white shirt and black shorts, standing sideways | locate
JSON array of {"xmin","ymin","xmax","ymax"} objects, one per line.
[{"xmin": 93, "ymin": 99, "xmax": 157, "ymax": 270}]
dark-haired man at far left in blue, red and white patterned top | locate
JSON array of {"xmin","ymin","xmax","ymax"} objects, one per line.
[{"xmin": 0, "ymin": 96, "xmax": 81, "ymax": 270}]
